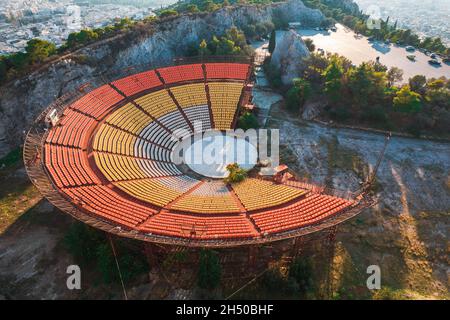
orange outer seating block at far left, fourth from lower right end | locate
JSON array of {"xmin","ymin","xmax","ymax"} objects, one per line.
[{"xmin": 44, "ymin": 144, "xmax": 99, "ymax": 188}]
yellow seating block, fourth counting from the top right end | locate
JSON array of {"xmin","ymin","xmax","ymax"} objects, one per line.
[{"xmin": 106, "ymin": 103, "xmax": 153, "ymax": 134}]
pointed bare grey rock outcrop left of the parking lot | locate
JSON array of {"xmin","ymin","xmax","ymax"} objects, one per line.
[{"xmin": 271, "ymin": 30, "xmax": 310, "ymax": 85}]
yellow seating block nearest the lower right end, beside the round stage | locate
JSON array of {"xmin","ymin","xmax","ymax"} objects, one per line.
[{"xmin": 232, "ymin": 178, "xmax": 306, "ymax": 211}]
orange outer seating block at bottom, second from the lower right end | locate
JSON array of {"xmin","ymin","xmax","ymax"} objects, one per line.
[{"xmin": 139, "ymin": 212, "xmax": 258, "ymax": 240}]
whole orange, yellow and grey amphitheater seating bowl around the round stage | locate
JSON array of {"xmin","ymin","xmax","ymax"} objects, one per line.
[{"xmin": 24, "ymin": 58, "xmax": 367, "ymax": 247}]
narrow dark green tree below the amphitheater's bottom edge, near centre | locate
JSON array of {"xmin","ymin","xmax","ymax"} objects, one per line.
[{"xmin": 197, "ymin": 249, "xmax": 222, "ymax": 290}]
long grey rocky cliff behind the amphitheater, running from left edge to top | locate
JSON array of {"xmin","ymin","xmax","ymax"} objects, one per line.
[{"xmin": 0, "ymin": 0, "xmax": 324, "ymax": 157}]
